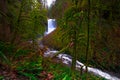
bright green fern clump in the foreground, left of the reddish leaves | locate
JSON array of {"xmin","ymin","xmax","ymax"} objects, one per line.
[{"xmin": 17, "ymin": 56, "xmax": 43, "ymax": 80}]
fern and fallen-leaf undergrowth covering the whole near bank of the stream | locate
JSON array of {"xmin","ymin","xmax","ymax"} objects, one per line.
[{"xmin": 0, "ymin": 42, "xmax": 104, "ymax": 80}]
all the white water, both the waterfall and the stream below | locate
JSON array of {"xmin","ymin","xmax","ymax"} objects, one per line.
[{"xmin": 44, "ymin": 19, "xmax": 120, "ymax": 80}]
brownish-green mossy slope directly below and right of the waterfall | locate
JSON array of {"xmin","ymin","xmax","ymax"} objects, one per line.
[{"xmin": 42, "ymin": 27, "xmax": 68, "ymax": 50}]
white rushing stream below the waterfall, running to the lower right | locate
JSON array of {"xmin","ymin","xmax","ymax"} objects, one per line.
[{"xmin": 44, "ymin": 50, "xmax": 120, "ymax": 80}]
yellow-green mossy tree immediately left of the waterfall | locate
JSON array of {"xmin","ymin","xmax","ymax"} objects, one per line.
[{"xmin": 30, "ymin": 2, "xmax": 47, "ymax": 47}]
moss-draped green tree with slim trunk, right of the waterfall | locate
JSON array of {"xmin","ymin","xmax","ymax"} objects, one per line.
[{"xmin": 61, "ymin": 5, "xmax": 85, "ymax": 70}]
